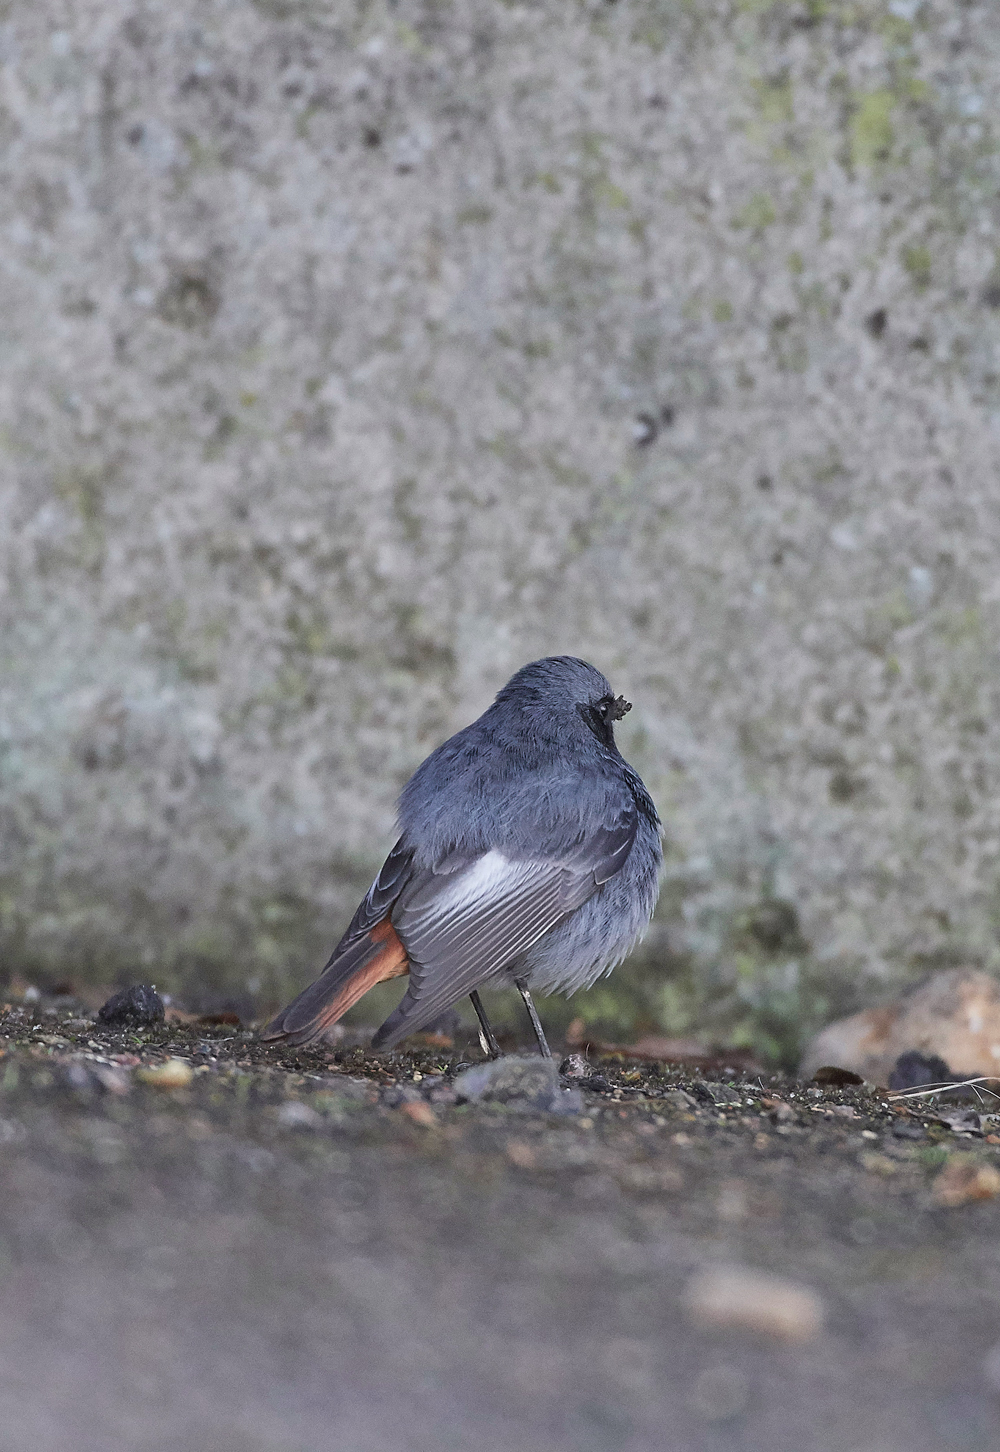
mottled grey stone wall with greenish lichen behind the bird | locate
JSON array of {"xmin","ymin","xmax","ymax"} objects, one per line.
[{"xmin": 0, "ymin": 0, "xmax": 1000, "ymax": 1051}]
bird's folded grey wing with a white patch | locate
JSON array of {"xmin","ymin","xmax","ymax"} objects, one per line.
[{"xmin": 373, "ymin": 803, "xmax": 637, "ymax": 1048}]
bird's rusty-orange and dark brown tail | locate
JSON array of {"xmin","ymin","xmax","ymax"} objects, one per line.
[{"xmin": 260, "ymin": 918, "xmax": 409, "ymax": 1044}]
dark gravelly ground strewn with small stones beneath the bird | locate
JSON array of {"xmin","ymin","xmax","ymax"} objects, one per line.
[{"xmin": 0, "ymin": 1003, "xmax": 1000, "ymax": 1452}]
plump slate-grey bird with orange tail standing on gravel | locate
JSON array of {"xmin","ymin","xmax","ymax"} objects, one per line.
[{"xmin": 261, "ymin": 655, "xmax": 662, "ymax": 1059}]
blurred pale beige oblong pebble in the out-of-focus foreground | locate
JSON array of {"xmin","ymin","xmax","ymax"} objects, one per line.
[{"xmin": 684, "ymin": 1266, "xmax": 824, "ymax": 1342}]
